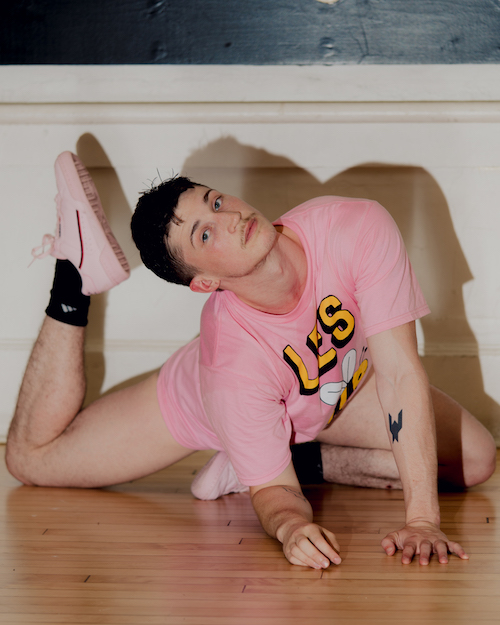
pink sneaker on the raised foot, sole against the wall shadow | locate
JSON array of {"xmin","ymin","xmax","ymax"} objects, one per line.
[{"xmin": 31, "ymin": 152, "xmax": 130, "ymax": 295}]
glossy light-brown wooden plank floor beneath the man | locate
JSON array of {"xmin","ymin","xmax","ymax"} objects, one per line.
[{"xmin": 0, "ymin": 444, "xmax": 500, "ymax": 625}]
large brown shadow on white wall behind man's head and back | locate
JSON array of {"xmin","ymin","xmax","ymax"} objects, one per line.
[{"xmin": 183, "ymin": 138, "xmax": 500, "ymax": 433}]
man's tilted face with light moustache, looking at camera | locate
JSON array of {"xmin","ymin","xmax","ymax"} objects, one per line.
[{"xmin": 169, "ymin": 186, "xmax": 277, "ymax": 280}]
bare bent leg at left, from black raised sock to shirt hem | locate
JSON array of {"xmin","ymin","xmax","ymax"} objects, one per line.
[{"xmin": 6, "ymin": 317, "xmax": 192, "ymax": 487}]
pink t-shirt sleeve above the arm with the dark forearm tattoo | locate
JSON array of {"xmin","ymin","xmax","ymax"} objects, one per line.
[{"xmin": 352, "ymin": 202, "xmax": 430, "ymax": 337}]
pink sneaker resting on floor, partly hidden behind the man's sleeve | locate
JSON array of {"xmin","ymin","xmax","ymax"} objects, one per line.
[{"xmin": 191, "ymin": 451, "xmax": 250, "ymax": 500}]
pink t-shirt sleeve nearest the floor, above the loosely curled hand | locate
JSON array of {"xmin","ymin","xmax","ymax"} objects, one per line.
[{"xmin": 201, "ymin": 364, "xmax": 292, "ymax": 486}]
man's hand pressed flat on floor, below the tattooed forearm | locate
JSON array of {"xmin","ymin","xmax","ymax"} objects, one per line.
[{"xmin": 381, "ymin": 521, "xmax": 469, "ymax": 565}]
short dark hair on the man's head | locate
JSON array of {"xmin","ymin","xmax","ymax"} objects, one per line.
[{"xmin": 130, "ymin": 176, "xmax": 201, "ymax": 286}]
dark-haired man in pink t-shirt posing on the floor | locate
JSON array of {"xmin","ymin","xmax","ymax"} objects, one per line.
[{"xmin": 7, "ymin": 153, "xmax": 496, "ymax": 568}]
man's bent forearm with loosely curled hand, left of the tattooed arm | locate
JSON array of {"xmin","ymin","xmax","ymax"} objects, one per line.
[{"xmin": 250, "ymin": 463, "xmax": 341, "ymax": 569}]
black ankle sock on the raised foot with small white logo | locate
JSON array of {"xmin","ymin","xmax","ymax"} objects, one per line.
[{"xmin": 45, "ymin": 260, "xmax": 90, "ymax": 327}]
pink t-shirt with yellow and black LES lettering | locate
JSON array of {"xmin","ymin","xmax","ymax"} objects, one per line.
[{"xmin": 159, "ymin": 196, "xmax": 429, "ymax": 485}]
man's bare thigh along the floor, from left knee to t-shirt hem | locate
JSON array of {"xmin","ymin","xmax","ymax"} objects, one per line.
[{"xmin": 28, "ymin": 374, "xmax": 193, "ymax": 488}]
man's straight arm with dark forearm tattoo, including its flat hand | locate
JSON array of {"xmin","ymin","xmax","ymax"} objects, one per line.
[{"xmin": 368, "ymin": 322, "xmax": 468, "ymax": 564}]
